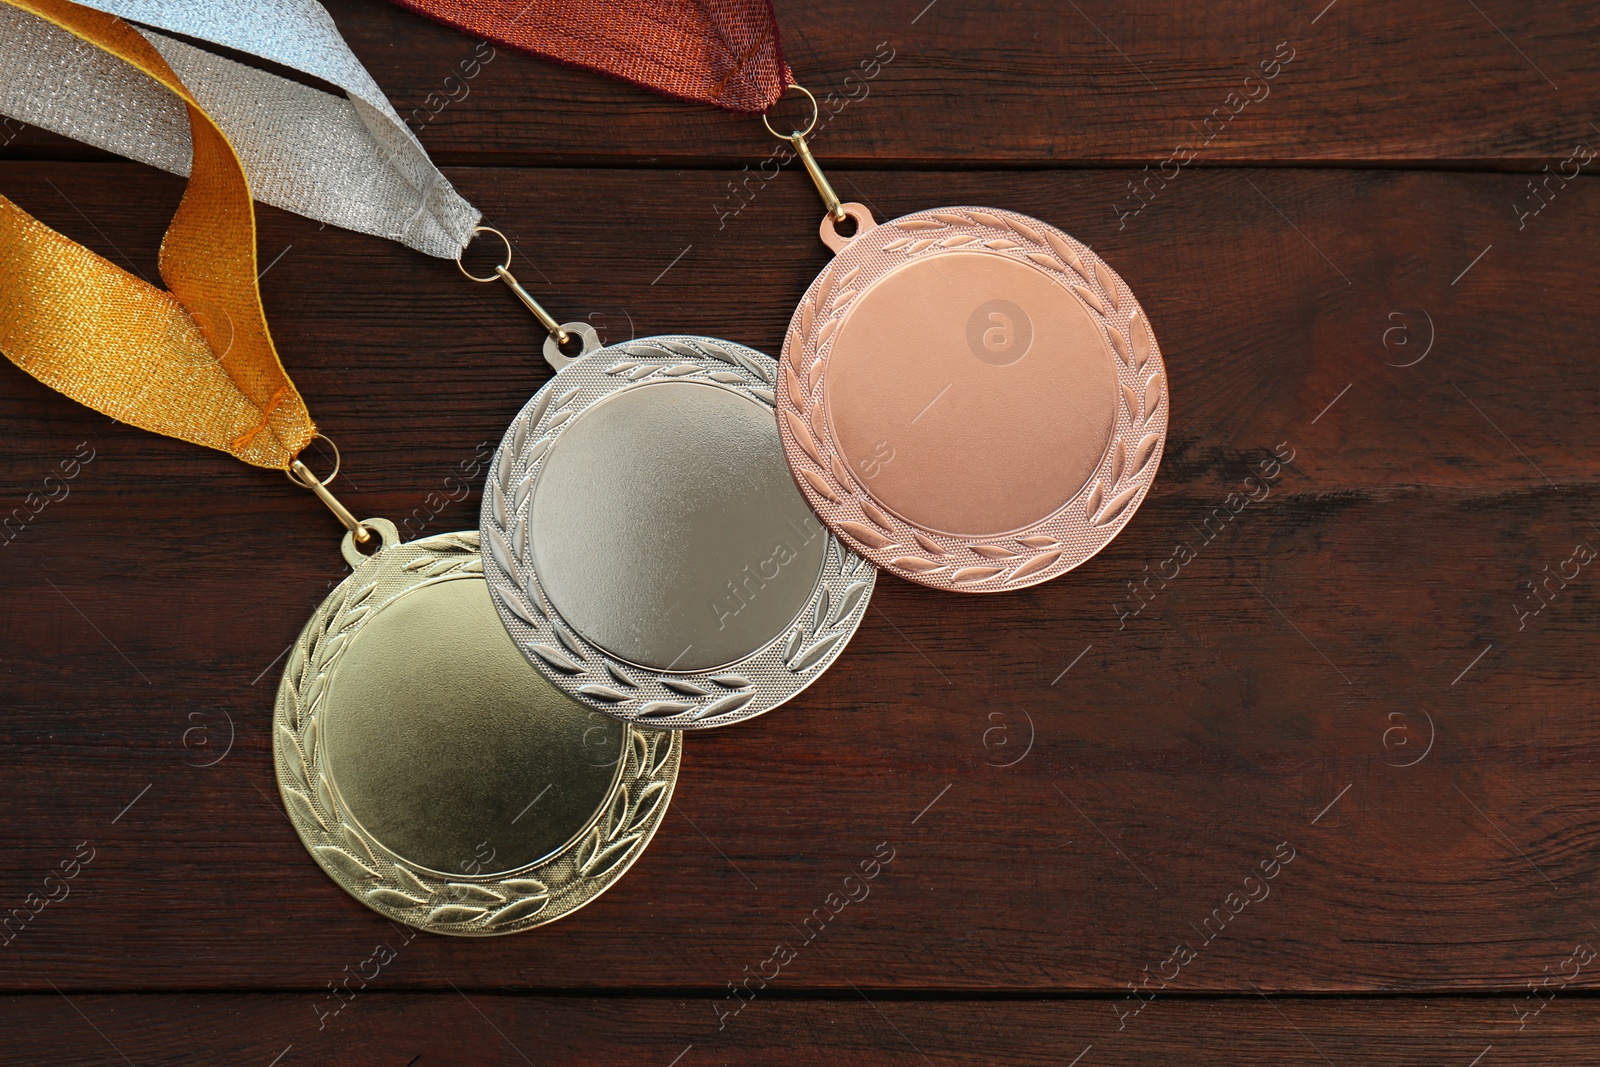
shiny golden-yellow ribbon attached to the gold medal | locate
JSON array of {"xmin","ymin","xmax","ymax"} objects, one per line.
[{"xmin": 0, "ymin": 0, "xmax": 317, "ymax": 469}]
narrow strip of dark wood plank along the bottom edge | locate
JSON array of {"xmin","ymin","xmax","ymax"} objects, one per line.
[{"xmin": 0, "ymin": 991, "xmax": 1600, "ymax": 1067}]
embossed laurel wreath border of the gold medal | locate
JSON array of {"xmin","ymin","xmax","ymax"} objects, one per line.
[{"xmin": 272, "ymin": 531, "xmax": 682, "ymax": 937}]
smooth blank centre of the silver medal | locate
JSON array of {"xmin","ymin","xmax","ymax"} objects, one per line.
[{"xmin": 530, "ymin": 381, "xmax": 827, "ymax": 670}]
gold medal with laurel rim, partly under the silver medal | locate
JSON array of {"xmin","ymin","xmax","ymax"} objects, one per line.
[{"xmin": 274, "ymin": 520, "xmax": 682, "ymax": 936}]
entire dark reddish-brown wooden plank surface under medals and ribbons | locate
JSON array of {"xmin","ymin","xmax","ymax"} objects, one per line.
[{"xmin": 0, "ymin": 0, "xmax": 1600, "ymax": 1067}]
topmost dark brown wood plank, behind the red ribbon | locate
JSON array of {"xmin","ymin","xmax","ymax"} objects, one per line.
[{"xmin": 0, "ymin": 0, "xmax": 1600, "ymax": 171}]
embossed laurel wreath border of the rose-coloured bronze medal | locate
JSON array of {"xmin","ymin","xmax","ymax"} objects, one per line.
[{"xmin": 778, "ymin": 208, "xmax": 1168, "ymax": 592}]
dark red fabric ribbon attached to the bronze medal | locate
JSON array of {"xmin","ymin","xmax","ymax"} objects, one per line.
[{"xmin": 395, "ymin": 0, "xmax": 790, "ymax": 114}]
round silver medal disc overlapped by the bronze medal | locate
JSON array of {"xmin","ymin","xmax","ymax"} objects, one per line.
[{"xmin": 482, "ymin": 334, "xmax": 875, "ymax": 729}]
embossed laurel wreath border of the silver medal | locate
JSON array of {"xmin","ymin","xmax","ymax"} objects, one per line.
[{"xmin": 480, "ymin": 334, "xmax": 877, "ymax": 729}]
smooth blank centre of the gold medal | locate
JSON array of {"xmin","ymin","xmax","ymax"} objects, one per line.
[{"xmin": 322, "ymin": 577, "xmax": 627, "ymax": 875}]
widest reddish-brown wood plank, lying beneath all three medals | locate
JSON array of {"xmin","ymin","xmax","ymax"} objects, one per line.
[{"xmin": 0, "ymin": 163, "xmax": 1600, "ymax": 991}]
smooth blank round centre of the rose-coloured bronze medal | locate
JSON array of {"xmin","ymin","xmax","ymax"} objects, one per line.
[{"xmin": 824, "ymin": 251, "xmax": 1117, "ymax": 537}]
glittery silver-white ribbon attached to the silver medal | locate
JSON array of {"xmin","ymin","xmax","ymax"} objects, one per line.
[{"xmin": 0, "ymin": 0, "xmax": 482, "ymax": 258}]
